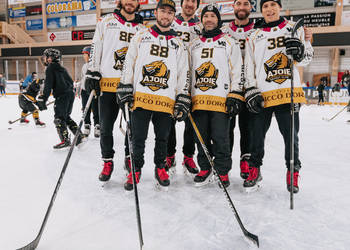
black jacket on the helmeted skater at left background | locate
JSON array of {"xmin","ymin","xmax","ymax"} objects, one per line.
[{"xmin": 43, "ymin": 62, "xmax": 73, "ymax": 101}]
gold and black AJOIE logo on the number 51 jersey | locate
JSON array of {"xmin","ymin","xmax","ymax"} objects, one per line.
[{"xmin": 194, "ymin": 61, "xmax": 219, "ymax": 91}]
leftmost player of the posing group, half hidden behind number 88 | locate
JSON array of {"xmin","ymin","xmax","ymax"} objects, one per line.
[{"xmin": 85, "ymin": 0, "xmax": 144, "ymax": 181}]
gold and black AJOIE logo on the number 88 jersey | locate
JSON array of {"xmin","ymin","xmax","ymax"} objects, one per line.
[{"xmin": 140, "ymin": 61, "xmax": 170, "ymax": 91}]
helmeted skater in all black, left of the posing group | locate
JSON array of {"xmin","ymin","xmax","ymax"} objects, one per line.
[{"xmin": 37, "ymin": 48, "xmax": 83, "ymax": 149}]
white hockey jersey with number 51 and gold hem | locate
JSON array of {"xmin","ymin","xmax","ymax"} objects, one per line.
[{"xmin": 190, "ymin": 33, "xmax": 242, "ymax": 113}]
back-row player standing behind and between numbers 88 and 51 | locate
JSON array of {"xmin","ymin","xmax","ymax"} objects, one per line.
[{"xmin": 166, "ymin": 0, "xmax": 200, "ymax": 174}]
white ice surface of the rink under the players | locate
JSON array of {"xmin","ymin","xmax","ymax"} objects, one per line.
[{"xmin": 0, "ymin": 96, "xmax": 350, "ymax": 250}]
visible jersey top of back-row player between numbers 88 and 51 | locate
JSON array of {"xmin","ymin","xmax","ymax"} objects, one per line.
[{"xmin": 171, "ymin": 17, "xmax": 201, "ymax": 46}]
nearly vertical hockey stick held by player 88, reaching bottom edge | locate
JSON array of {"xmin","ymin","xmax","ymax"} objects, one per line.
[{"xmin": 124, "ymin": 103, "xmax": 143, "ymax": 250}]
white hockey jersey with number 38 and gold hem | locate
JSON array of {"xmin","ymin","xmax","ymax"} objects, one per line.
[{"xmin": 245, "ymin": 20, "xmax": 313, "ymax": 107}]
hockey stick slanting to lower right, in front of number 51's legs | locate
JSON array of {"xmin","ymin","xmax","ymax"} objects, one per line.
[{"xmin": 188, "ymin": 113, "xmax": 259, "ymax": 247}]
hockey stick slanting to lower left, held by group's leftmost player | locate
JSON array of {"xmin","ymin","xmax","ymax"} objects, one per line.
[{"xmin": 18, "ymin": 90, "xmax": 95, "ymax": 250}]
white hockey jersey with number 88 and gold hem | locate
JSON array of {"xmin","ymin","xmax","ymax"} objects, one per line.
[{"xmin": 121, "ymin": 28, "xmax": 189, "ymax": 115}]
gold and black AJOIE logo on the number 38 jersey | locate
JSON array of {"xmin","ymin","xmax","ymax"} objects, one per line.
[{"xmin": 264, "ymin": 52, "xmax": 291, "ymax": 84}]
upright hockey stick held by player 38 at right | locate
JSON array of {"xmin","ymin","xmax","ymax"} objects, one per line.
[{"xmin": 289, "ymin": 18, "xmax": 304, "ymax": 209}]
